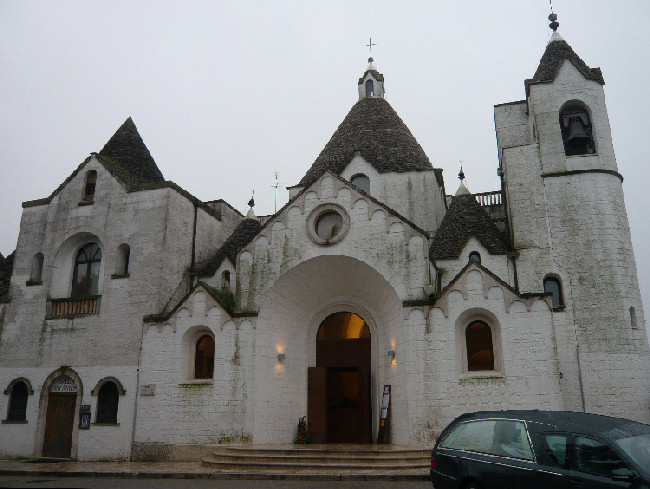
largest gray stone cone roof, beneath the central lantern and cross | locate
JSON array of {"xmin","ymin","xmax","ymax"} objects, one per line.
[{"xmin": 298, "ymin": 97, "xmax": 433, "ymax": 186}]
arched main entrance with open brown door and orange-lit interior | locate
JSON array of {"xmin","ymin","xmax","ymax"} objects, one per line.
[{"xmin": 307, "ymin": 312, "xmax": 372, "ymax": 443}]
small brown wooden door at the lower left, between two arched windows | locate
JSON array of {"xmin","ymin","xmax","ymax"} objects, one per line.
[{"xmin": 43, "ymin": 393, "xmax": 77, "ymax": 458}]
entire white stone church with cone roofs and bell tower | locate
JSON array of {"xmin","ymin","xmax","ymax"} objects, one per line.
[{"xmin": 0, "ymin": 22, "xmax": 650, "ymax": 460}]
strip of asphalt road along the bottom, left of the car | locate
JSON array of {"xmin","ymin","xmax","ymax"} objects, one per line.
[{"xmin": 0, "ymin": 476, "xmax": 431, "ymax": 489}]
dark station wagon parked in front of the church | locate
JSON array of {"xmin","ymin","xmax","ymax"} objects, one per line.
[{"xmin": 430, "ymin": 411, "xmax": 650, "ymax": 489}]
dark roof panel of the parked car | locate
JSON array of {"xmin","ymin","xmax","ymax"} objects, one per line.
[{"xmin": 457, "ymin": 410, "xmax": 650, "ymax": 440}]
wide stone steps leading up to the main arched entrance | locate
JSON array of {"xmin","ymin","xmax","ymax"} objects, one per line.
[{"xmin": 202, "ymin": 444, "xmax": 431, "ymax": 479}]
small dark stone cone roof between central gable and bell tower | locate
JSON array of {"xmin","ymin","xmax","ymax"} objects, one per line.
[{"xmin": 429, "ymin": 195, "xmax": 508, "ymax": 260}]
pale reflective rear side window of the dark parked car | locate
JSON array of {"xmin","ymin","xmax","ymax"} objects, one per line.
[{"xmin": 440, "ymin": 419, "xmax": 533, "ymax": 460}]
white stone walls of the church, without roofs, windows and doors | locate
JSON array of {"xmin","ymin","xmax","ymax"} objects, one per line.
[{"xmin": 0, "ymin": 32, "xmax": 650, "ymax": 460}]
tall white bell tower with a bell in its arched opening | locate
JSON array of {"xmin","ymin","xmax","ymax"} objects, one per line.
[{"xmin": 495, "ymin": 13, "xmax": 650, "ymax": 423}]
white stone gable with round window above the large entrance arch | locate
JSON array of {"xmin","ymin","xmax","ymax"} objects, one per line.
[{"xmin": 237, "ymin": 172, "xmax": 428, "ymax": 311}]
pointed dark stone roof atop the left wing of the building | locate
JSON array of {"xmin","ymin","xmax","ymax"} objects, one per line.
[{"xmin": 99, "ymin": 117, "xmax": 165, "ymax": 188}]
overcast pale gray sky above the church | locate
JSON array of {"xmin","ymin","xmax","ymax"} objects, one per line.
[{"xmin": 0, "ymin": 0, "xmax": 650, "ymax": 332}]
